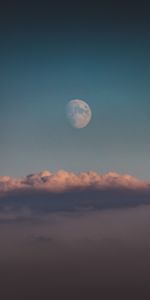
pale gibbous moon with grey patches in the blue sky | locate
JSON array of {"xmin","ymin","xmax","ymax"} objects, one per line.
[{"xmin": 66, "ymin": 99, "xmax": 92, "ymax": 129}]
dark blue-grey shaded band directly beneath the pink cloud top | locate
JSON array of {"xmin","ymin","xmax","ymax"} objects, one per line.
[{"xmin": 0, "ymin": 188, "xmax": 150, "ymax": 219}]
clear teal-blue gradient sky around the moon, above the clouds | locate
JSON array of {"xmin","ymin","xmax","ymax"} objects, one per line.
[{"xmin": 0, "ymin": 0, "xmax": 150, "ymax": 179}]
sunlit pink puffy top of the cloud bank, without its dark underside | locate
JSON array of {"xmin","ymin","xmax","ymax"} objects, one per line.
[{"xmin": 0, "ymin": 170, "xmax": 150, "ymax": 195}]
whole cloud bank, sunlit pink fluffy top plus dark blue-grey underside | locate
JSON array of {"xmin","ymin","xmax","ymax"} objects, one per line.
[{"xmin": 0, "ymin": 170, "xmax": 150, "ymax": 220}]
